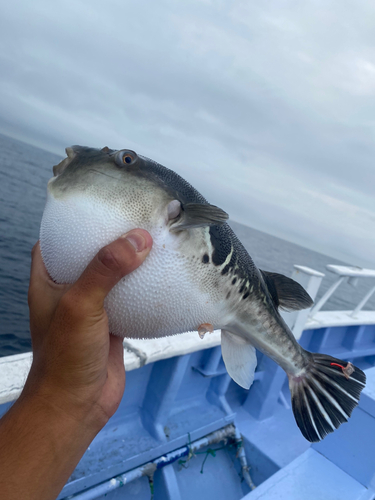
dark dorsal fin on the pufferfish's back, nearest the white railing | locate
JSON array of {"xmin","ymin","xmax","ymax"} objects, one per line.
[{"xmin": 260, "ymin": 270, "xmax": 314, "ymax": 311}]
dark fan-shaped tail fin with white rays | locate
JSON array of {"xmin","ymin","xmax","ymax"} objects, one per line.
[{"xmin": 288, "ymin": 353, "xmax": 366, "ymax": 442}]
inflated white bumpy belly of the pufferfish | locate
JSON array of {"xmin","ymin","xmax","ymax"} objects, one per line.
[{"xmin": 40, "ymin": 191, "xmax": 226, "ymax": 338}]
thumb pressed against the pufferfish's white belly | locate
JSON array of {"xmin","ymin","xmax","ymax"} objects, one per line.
[{"xmin": 67, "ymin": 229, "xmax": 152, "ymax": 314}]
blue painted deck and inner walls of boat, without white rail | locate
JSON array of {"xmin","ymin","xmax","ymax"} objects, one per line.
[{"xmin": 55, "ymin": 325, "xmax": 375, "ymax": 500}]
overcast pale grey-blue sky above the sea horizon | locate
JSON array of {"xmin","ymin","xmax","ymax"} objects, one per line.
[{"xmin": 0, "ymin": 0, "xmax": 375, "ymax": 267}]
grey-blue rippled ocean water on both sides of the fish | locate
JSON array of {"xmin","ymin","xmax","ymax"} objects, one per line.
[{"xmin": 0, "ymin": 134, "xmax": 375, "ymax": 356}]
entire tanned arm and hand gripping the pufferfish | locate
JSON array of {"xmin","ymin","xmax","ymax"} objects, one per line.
[{"xmin": 0, "ymin": 229, "xmax": 152, "ymax": 500}]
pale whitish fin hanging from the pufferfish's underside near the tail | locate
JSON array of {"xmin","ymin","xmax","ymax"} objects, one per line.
[{"xmin": 221, "ymin": 330, "xmax": 257, "ymax": 389}]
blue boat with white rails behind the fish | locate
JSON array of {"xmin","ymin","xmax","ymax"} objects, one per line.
[{"xmin": 0, "ymin": 265, "xmax": 375, "ymax": 500}]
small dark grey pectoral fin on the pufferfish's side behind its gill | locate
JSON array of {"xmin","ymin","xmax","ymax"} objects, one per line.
[{"xmin": 170, "ymin": 202, "xmax": 228, "ymax": 232}]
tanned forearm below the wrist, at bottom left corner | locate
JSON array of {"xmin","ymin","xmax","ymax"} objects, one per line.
[{"xmin": 0, "ymin": 384, "xmax": 100, "ymax": 500}]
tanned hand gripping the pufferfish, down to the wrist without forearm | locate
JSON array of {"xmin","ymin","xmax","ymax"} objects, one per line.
[{"xmin": 23, "ymin": 229, "xmax": 152, "ymax": 430}]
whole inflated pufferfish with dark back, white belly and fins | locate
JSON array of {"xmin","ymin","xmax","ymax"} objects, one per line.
[{"xmin": 40, "ymin": 146, "xmax": 366, "ymax": 442}]
